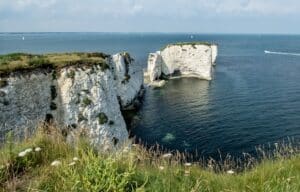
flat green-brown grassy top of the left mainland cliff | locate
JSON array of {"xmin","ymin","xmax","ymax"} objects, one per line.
[{"xmin": 0, "ymin": 53, "xmax": 108, "ymax": 75}]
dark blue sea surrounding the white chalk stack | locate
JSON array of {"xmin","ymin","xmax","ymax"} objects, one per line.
[{"xmin": 0, "ymin": 33, "xmax": 300, "ymax": 156}]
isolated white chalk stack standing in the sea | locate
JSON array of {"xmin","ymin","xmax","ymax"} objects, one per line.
[{"xmin": 147, "ymin": 43, "xmax": 218, "ymax": 81}]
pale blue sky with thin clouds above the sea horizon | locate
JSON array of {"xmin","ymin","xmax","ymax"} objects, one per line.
[{"xmin": 0, "ymin": 0, "xmax": 300, "ymax": 34}]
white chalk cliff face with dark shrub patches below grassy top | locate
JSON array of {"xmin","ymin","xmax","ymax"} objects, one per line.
[{"xmin": 0, "ymin": 53, "xmax": 143, "ymax": 148}]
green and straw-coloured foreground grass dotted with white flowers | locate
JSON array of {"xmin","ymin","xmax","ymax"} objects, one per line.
[{"xmin": 0, "ymin": 126, "xmax": 300, "ymax": 192}]
